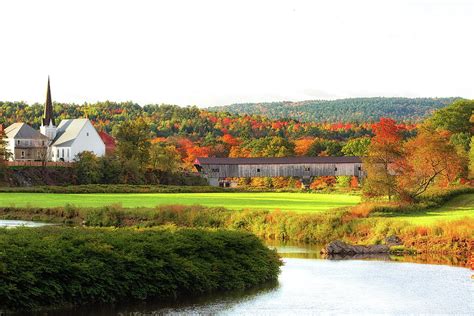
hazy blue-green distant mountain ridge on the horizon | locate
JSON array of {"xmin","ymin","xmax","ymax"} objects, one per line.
[{"xmin": 208, "ymin": 97, "xmax": 460, "ymax": 122}]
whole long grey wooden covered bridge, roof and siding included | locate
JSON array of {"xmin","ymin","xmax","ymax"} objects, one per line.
[{"xmin": 194, "ymin": 157, "xmax": 363, "ymax": 186}]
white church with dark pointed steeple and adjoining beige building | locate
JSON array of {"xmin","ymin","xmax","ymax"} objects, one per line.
[{"xmin": 5, "ymin": 78, "xmax": 105, "ymax": 162}]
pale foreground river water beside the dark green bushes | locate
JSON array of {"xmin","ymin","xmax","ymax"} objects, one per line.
[{"xmin": 24, "ymin": 258, "xmax": 474, "ymax": 316}]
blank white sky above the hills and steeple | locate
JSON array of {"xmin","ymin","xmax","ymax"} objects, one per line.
[{"xmin": 0, "ymin": 0, "xmax": 474, "ymax": 107}]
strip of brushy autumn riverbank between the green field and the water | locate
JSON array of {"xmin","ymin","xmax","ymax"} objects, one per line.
[{"xmin": 0, "ymin": 198, "xmax": 474, "ymax": 264}]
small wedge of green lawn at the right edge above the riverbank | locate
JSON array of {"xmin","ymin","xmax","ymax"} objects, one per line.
[{"xmin": 382, "ymin": 194, "xmax": 474, "ymax": 225}]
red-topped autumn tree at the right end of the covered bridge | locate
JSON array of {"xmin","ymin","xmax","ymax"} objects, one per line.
[{"xmin": 363, "ymin": 118, "xmax": 403, "ymax": 200}]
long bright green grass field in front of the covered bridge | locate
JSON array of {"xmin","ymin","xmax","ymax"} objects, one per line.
[{"xmin": 0, "ymin": 192, "xmax": 361, "ymax": 212}]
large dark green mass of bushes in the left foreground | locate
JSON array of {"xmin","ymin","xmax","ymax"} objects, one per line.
[{"xmin": 0, "ymin": 227, "xmax": 281, "ymax": 310}]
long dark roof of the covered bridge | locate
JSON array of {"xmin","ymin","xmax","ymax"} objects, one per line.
[{"xmin": 194, "ymin": 157, "xmax": 362, "ymax": 165}]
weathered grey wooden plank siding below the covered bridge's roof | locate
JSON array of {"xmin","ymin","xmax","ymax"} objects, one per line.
[{"xmin": 202, "ymin": 163, "xmax": 362, "ymax": 178}]
